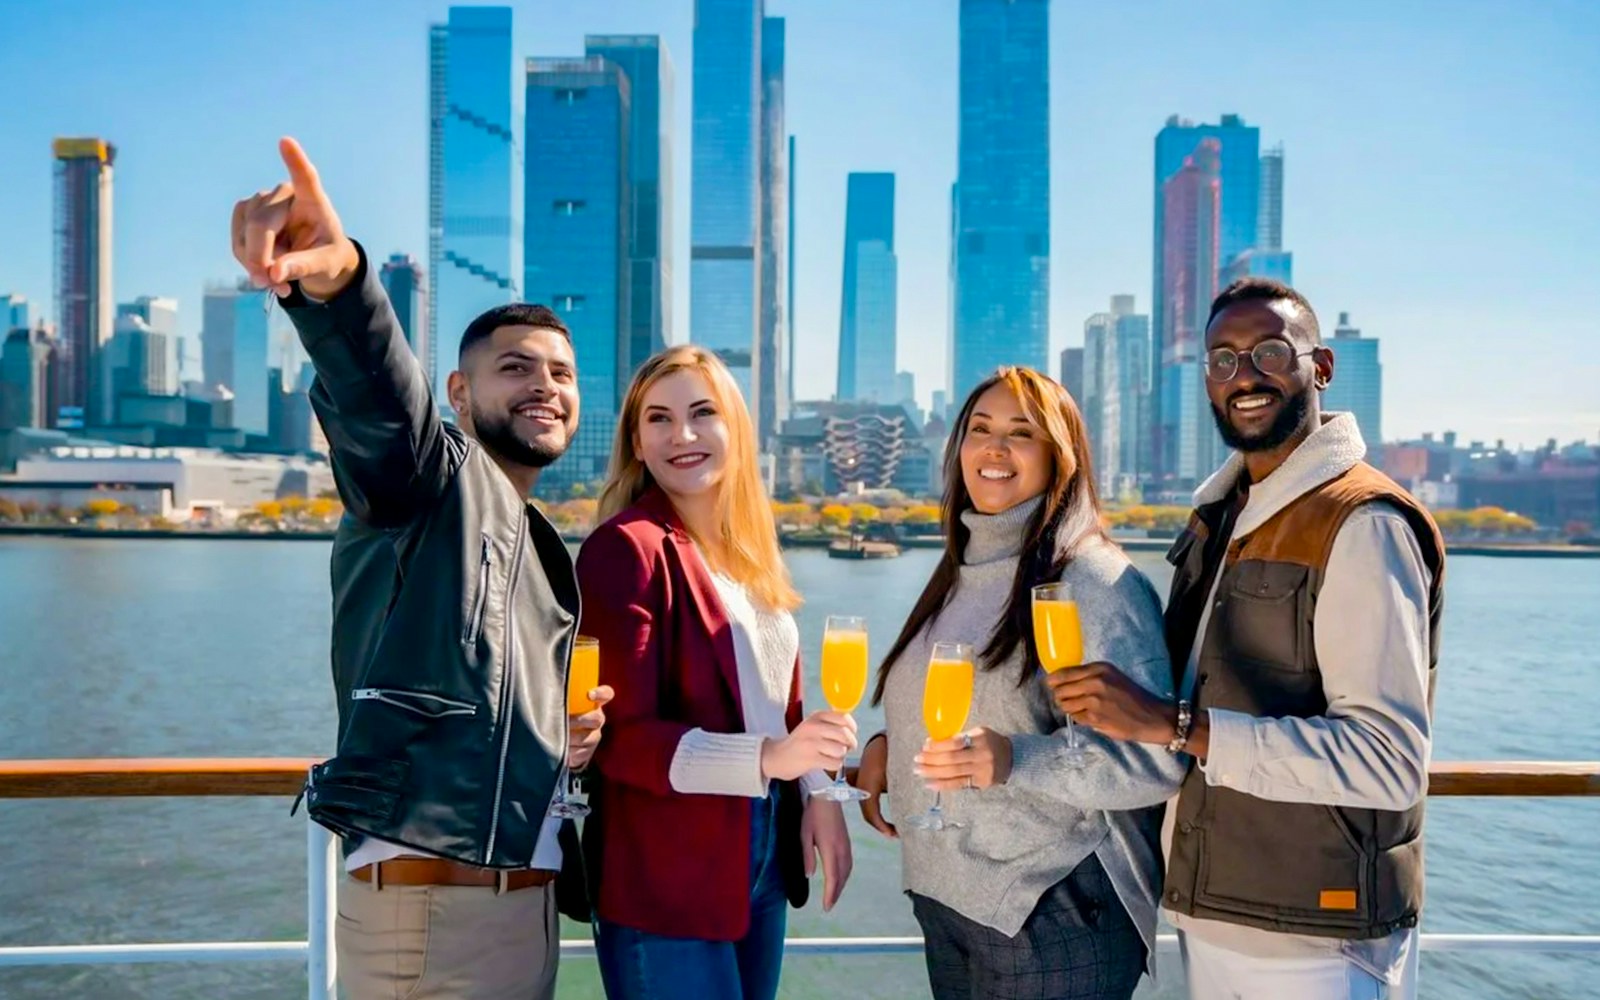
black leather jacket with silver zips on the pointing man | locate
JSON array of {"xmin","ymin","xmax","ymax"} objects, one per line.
[{"xmin": 283, "ymin": 246, "xmax": 579, "ymax": 869}]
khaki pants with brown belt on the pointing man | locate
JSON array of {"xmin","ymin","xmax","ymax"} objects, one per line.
[{"xmin": 334, "ymin": 877, "xmax": 560, "ymax": 1000}]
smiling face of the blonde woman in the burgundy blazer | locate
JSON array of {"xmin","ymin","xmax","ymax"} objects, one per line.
[{"xmin": 634, "ymin": 368, "xmax": 730, "ymax": 501}]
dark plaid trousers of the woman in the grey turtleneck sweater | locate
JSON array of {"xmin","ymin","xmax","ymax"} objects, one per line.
[{"xmin": 910, "ymin": 854, "xmax": 1144, "ymax": 1000}]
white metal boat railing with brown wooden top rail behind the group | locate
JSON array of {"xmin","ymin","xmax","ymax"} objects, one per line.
[{"xmin": 0, "ymin": 757, "xmax": 1600, "ymax": 1000}]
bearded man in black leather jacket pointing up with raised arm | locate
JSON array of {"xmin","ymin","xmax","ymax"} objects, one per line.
[{"xmin": 232, "ymin": 139, "xmax": 610, "ymax": 1000}]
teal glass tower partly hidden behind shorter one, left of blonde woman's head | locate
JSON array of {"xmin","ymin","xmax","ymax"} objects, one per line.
[{"xmin": 584, "ymin": 35, "xmax": 674, "ymax": 374}]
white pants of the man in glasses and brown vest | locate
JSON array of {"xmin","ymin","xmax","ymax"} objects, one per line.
[{"xmin": 1178, "ymin": 931, "xmax": 1419, "ymax": 1000}]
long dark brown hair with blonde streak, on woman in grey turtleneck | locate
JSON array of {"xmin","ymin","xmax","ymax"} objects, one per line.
[{"xmin": 872, "ymin": 365, "xmax": 1106, "ymax": 704}]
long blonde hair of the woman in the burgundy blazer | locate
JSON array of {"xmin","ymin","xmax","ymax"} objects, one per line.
[{"xmin": 597, "ymin": 344, "xmax": 800, "ymax": 611}]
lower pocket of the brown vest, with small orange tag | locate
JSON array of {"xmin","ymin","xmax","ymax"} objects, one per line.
[{"xmin": 1195, "ymin": 787, "xmax": 1373, "ymax": 934}]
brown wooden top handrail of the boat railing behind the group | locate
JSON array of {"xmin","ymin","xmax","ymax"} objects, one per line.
[{"xmin": 0, "ymin": 757, "xmax": 1600, "ymax": 798}]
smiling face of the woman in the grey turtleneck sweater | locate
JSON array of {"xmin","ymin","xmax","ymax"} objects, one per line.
[{"xmin": 960, "ymin": 382, "xmax": 1054, "ymax": 514}]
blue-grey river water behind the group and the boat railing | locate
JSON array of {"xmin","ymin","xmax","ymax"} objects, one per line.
[{"xmin": 0, "ymin": 538, "xmax": 1600, "ymax": 1000}]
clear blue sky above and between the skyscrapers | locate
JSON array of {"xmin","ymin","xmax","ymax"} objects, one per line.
[{"xmin": 0, "ymin": 0, "xmax": 1600, "ymax": 443}]
